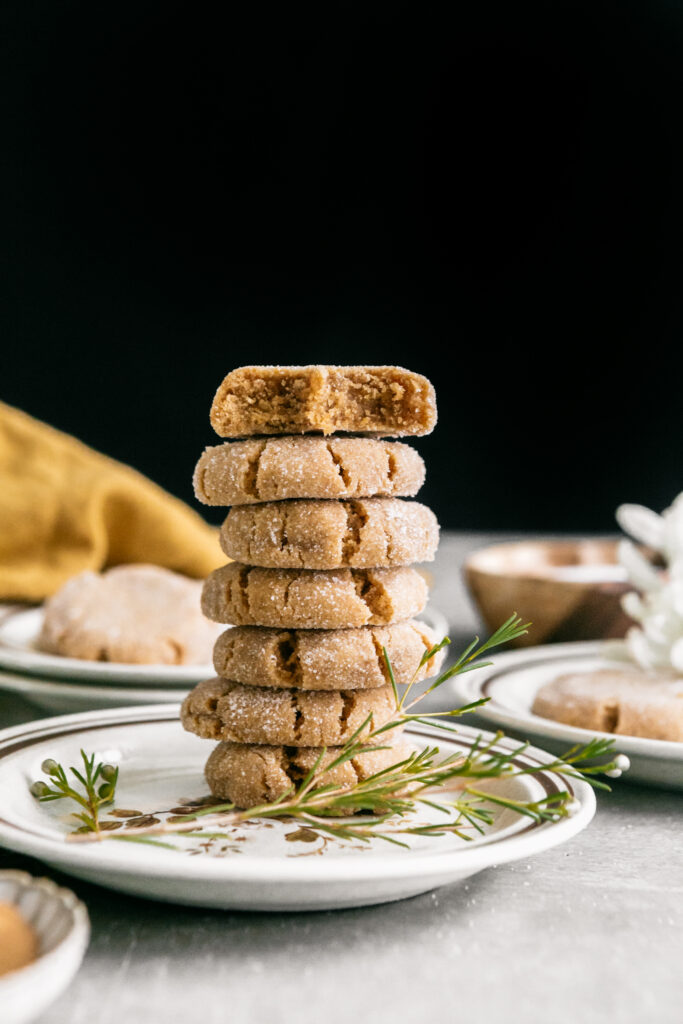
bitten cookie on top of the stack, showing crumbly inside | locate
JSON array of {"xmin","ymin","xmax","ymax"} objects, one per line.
[{"xmin": 206, "ymin": 366, "xmax": 436, "ymax": 437}]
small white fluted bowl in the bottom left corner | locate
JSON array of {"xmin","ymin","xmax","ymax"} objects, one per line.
[{"xmin": 0, "ymin": 870, "xmax": 90, "ymax": 1024}]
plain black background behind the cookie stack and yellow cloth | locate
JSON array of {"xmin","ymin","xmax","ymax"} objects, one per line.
[{"xmin": 0, "ymin": 0, "xmax": 683, "ymax": 531}]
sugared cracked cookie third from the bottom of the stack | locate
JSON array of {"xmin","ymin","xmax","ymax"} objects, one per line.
[{"xmin": 213, "ymin": 620, "xmax": 445, "ymax": 690}]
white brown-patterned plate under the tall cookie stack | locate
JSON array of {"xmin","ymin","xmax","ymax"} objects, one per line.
[{"xmin": 0, "ymin": 705, "xmax": 595, "ymax": 910}]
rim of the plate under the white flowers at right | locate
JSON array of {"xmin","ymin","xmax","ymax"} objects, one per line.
[{"xmin": 453, "ymin": 640, "xmax": 683, "ymax": 762}]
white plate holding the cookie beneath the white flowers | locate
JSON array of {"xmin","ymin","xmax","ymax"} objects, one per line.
[{"xmin": 454, "ymin": 640, "xmax": 683, "ymax": 790}]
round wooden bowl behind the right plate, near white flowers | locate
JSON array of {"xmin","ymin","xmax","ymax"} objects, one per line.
[{"xmin": 464, "ymin": 539, "xmax": 633, "ymax": 647}]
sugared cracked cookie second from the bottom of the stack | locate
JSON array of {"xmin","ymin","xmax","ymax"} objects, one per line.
[{"xmin": 180, "ymin": 679, "xmax": 396, "ymax": 746}]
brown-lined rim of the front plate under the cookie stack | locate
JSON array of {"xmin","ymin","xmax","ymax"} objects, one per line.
[{"xmin": 0, "ymin": 703, "xmax": 596, "ymax": 886}]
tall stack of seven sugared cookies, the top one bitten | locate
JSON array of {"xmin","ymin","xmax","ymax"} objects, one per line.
[{"xmin": 181, "ymin": 367, "xmax": 442, "ymax": 807}]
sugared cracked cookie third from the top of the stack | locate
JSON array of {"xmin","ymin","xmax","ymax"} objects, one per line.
[{"xmin": 220, "ymin": 498, "xmax": 438, "ymax": 569}]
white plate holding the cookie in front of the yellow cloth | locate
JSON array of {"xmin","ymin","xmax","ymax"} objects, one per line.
[{"xmin": 0, "ymin": 605, "xmax": 449, "ymax": 688}]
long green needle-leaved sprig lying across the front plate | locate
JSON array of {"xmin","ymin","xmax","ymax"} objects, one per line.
[{"xmin": 45, "ymin": 615, "xmax": 628, "ymax": 846}]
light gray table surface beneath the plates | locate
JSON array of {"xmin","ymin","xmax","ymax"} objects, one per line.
[{"xmin": 0, "ymin": 534, "xmax": 683, "ymax": 1024}]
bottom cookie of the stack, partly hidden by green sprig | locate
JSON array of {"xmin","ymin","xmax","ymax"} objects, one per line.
[{"xmin": 204, "ymin": 730, "xmax": 413, "ymax": 808}]
